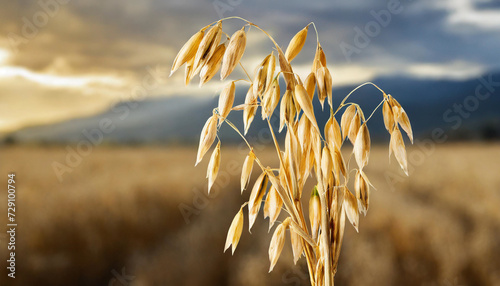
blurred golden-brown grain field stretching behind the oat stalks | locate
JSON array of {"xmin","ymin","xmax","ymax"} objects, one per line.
[{"xmin": 0, "ymin": 143, "xmax": 500, "ymax": 286}]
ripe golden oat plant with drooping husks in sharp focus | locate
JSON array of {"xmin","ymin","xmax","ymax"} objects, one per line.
[{"xmin": 171, "ymin": 17, "xmax": 413, "ymax": 286}]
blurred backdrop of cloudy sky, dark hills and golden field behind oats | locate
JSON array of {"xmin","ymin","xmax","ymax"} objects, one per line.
[{"xmin": 0, "ymin": 0, "xmax": 500, "ymax": 286}]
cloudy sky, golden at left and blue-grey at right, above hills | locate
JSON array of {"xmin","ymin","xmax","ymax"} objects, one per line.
[{"xmin": 0, "ymin": 0, "xmax": 500, "ymax": 132}]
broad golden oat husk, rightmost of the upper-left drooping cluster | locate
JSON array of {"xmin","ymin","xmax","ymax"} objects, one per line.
[{"xmin": 220, "ymin": 27, "xmax": 247, "ymax": 80}]
